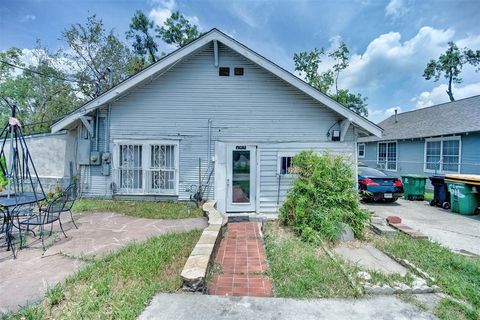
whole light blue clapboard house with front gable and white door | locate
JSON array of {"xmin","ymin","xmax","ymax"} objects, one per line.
[{"xmin": 52, "ymin": 29, "xmax": 381, "ymax": 213}]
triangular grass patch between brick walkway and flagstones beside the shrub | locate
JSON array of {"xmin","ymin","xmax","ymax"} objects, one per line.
[{"xmin": 265, "ymin": 222, "xmax": 355, "ymax": 298}]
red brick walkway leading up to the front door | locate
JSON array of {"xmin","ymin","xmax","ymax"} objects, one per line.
[{"xmin": 208, "ymin": 222, "xmax": 273, "ymax": 297}]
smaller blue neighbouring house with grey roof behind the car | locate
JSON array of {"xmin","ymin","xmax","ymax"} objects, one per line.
[{"xmin": 358, "ymin": 95, "xmax": 480, "ymax": 181}]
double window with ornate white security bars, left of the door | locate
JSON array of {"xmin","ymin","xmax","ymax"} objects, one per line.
[{"xmin": 114, "ymin": 142, "xmax": 178, "ymax": 195}]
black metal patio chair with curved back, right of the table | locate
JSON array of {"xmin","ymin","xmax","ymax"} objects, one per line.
[{"xmin": 12, "ymin": 193, "xmax": 68, "ymax": 251}]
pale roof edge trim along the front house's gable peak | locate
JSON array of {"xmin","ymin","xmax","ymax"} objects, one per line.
[{"xmin": 51, "ymin": 29, "xmax": 382, "ymax": 137}]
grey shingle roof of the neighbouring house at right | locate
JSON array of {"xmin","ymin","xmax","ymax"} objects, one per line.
[{"xmin": 358, "ymin": 95, "xmax": 480, "ymax": 142}]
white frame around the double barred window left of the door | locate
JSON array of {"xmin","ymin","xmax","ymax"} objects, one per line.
[{"xmin": 113, "ymin": 139, "xmax": 180, "ymax": 196}]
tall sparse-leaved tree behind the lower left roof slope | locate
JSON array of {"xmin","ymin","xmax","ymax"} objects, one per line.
[{"xmin": 62, "ymin": 15, "xmax": 135, "ymax": 98}]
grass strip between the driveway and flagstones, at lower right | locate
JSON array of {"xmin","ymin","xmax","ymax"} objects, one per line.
[{"xmin": 374, "ymin": 234, "xmax": 480, "ymax": 319}]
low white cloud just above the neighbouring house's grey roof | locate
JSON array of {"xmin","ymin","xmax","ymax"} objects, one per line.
[{"xmin": 412, "ymin": 82, "xmax": 480, "ymax": 109}]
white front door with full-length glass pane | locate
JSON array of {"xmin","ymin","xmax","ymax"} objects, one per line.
[{"xmin": 227, "ymin": 145, "xmax": 257, "ymax": 212}]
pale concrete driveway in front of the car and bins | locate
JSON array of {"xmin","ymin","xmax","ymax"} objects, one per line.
[{"xmin": 362, "ymin": 199, "xmax": 480, "ymax": 256}]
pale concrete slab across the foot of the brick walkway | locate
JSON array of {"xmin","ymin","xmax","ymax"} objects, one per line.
[{"xmin": 139, "ymin": 294, "xmax": 436, "ymax": 320}]
